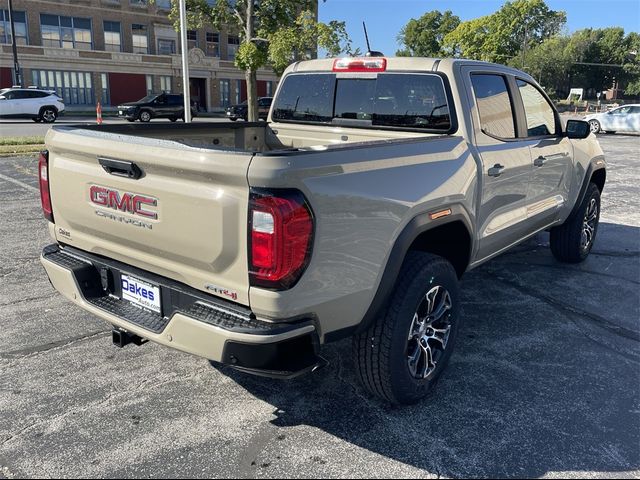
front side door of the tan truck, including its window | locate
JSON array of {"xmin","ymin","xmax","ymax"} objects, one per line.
[{"xmin": 515, "ymin": 78, "xmax": 573, "ymax": 230}]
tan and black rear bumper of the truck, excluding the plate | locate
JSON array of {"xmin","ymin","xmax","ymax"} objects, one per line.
[{"xmin": 41, "ymin": 245, "xmax": 322, "ymax": 378}]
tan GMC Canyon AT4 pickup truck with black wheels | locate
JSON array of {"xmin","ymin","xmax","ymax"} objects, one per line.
[{"xmin": 39, "ymin": 57, "xmax": 606, "ymax": 404}]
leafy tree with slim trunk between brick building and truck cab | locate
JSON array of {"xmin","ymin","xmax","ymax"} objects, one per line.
[{"xmin": 160, "ymin": 0, "xmax": 351, "ymax": 121}]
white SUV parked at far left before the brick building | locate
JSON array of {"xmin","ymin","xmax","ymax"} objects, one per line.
[{"xmin": 0, "ymin": 87, "xmax": 64, "ymax": 123}]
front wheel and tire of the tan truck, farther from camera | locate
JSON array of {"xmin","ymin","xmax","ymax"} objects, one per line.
[{"xmin": 550, "ymin": 182, "xmax": 600, "ymax": 263}]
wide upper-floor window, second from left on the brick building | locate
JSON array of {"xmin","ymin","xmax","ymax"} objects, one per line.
[{"xmin": 40, "ymin": 13, "xmax": 92, "ymax": 50}]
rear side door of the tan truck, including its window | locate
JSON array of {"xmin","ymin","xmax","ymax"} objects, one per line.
[{"xmin": 463, "ymin": 67, "xmax": 532, "ymax": 260}]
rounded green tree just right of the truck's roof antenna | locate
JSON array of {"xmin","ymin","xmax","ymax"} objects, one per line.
[{"xmin": 396, "ymin": 10, "xmax": 460, "ymax": 57}]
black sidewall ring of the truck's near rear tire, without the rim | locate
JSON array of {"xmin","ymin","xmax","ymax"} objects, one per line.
[{"xmin": 390, "ymin": 258, "xmax": 460, "ymax": 403}]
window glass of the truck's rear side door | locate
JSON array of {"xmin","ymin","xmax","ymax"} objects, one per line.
[{"xmin": 471, "ymin": 74, "xmax": 516, "ymax": 138}]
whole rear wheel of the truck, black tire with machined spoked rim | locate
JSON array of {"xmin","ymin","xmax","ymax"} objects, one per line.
[{"xmin": 353, "ymin": 252, "xmax": 460, "ymax": 404}]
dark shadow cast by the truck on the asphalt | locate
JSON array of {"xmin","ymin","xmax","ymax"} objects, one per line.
[{"xmin": 216, "ymin": 223, "xmax": 640, "ymax": 478}]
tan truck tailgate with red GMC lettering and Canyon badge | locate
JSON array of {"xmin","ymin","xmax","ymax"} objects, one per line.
[{"xmin": 46, "ymin": 127, "xmax": 252, "ymax": 305}]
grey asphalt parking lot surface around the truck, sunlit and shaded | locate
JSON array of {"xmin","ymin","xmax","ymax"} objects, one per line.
[{"xmin": 0, "ymin": 135, "xmax": 640, "ymax": 478}]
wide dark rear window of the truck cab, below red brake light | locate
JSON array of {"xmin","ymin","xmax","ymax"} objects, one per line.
[{"xmin": 272, "ymin": 73, "xmax": 452, "ymax": 132}]
